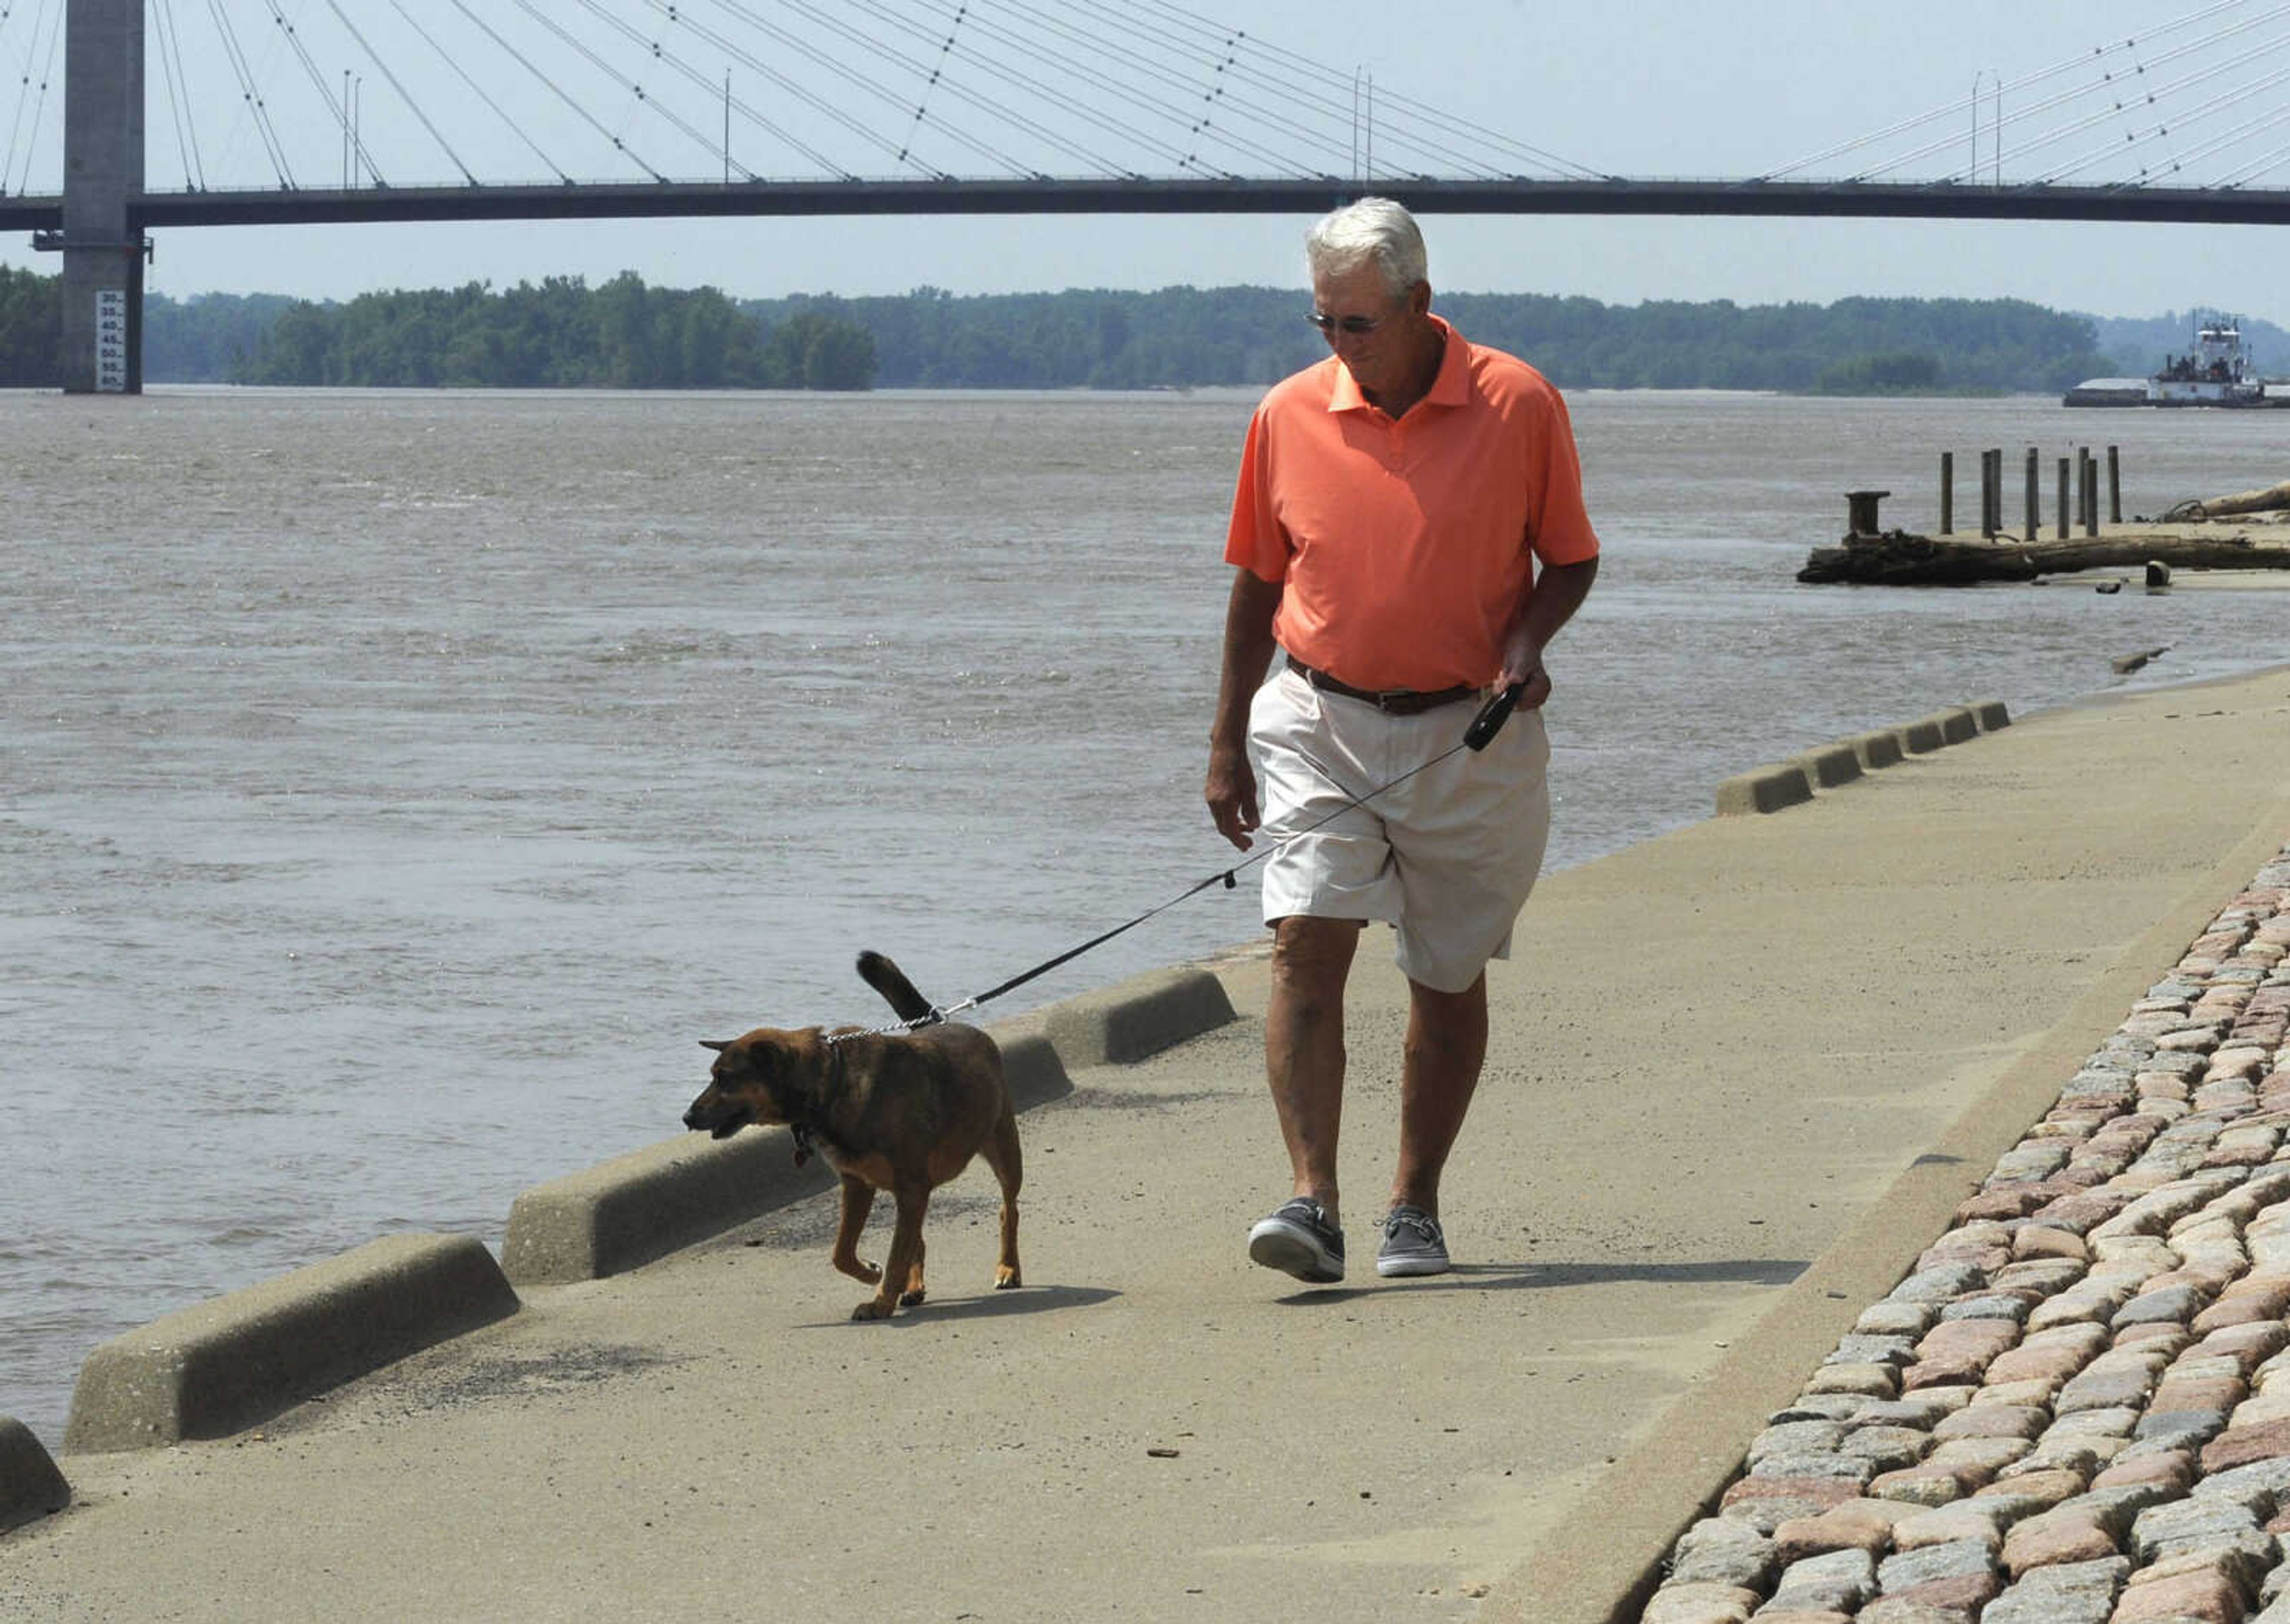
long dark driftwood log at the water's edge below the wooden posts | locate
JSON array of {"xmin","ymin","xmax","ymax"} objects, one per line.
[{"xmin": 1797, "ymin": 529, "xmax": 2290, "ymax": 587}]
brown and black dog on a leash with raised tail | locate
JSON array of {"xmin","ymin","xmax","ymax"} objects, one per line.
[{"xmin": 685, "ymin": 953, "xmax": 1023, "ymax": 1319}]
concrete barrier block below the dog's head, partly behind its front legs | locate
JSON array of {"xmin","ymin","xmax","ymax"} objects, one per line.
[{"xmin": 502, "ymin": 1127, "xmax": 836, "ymax": 1285}]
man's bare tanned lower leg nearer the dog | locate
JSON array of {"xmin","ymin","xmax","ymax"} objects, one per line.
[{"xmin": 1264, "ymin": 914, "xmax": 1356, "ymax": 1223}]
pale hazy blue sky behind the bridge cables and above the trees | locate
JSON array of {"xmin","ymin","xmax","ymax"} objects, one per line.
[{"xmin": 0, "ymin": 0, "xmax": 2290, "ymax": 326}]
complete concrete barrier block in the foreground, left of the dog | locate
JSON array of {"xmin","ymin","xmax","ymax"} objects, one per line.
[{"xmin": 64, "ymin": 1235, "xmax": 518, "ymax": 1455}]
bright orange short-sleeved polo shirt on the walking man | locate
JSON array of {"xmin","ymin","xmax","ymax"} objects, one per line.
[{"xmin": 1225, "ymin": 316, "xmax": 1598, "ymax": 689}]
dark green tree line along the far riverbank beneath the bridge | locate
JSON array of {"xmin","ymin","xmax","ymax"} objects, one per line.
[{"xmin": 0, "ymin": 268, "xmax": 2150, "ymax": 394}]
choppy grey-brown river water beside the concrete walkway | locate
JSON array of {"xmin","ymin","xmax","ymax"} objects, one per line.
[{"xmin": 0, "ymin": 389, "xmax": 2290, "ymax": 1448}]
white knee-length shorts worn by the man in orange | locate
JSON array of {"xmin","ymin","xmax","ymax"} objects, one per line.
[{"xmin": 1248, "ymin": 662, "xmax": 1551, "ymax": 992}]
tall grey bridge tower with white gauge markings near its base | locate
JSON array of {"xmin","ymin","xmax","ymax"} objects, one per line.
[{"xmin": 62, "ymin": 0, "xmax": 147, "ymax": 394}]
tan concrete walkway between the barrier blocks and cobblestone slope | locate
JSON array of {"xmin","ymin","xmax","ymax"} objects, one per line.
[{"xmin": 13, "ymin": 671, "xmax": 2290, "ymax": 1624}]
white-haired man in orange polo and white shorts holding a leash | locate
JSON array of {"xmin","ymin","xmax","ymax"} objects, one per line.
[{"xmin": 1207, "ymin": 197, "xmax": 1598, "ymax": 1283}]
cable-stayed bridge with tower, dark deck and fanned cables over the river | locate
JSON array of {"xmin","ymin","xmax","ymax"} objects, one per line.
[{"xmin": 13, "ymin": 0, "xmax": 2290, "ymax": 389}]
